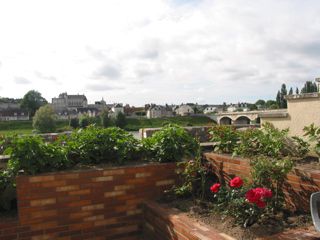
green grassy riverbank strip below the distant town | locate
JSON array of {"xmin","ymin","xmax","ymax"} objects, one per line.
[{"xmin": 0, "ymin": 116, "xmax": 213, "ymax": 134}]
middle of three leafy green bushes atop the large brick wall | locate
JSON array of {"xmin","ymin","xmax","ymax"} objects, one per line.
[{"xmin": 65, "ymin": 126, "xmax": 140, "ymax": 164}]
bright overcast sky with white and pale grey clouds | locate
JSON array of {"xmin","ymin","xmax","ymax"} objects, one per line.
[{"xmin": 0, "ymin": 0, "xmax": 320, "ymax": 105}]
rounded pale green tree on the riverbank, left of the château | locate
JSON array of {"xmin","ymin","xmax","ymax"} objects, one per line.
[{"xmin": 33, "ymin": 105, "xmax": 56, "ymax": 133}]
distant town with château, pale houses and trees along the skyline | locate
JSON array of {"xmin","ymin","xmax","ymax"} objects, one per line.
[{"xmin": 0, "ymin": 81, "xmax": 318, "ymax": 124}]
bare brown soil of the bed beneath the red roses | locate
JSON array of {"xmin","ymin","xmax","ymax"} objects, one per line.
[{"xmin": 160, "ymin": 198, "xmax": 313, "ymax": 240}]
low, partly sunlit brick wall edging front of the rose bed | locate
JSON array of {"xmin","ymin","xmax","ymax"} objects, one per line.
[{"xmin": 143, "ymin": 202, "xmax": 224, "ymax": 240}]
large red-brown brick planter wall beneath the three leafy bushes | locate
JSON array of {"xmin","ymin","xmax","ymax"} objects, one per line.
[{"xmin": 0, "ymin": 163, "xmax": 177, "ymax": 240}]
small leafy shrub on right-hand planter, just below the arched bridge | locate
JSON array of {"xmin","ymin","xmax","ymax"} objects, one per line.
[{"xmin": 209, "ymin": 125, "xmax": 239, "ymax": 153}]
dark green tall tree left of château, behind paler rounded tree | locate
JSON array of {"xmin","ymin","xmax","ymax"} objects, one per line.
[{"xmin": 21, "ymin": 90, "xmax": 48, "ymax": 117}]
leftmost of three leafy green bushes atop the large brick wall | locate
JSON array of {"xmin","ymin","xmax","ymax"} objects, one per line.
[{"xmin": 5, "ymin": 136, "xmax": 70, "ymax": 174}]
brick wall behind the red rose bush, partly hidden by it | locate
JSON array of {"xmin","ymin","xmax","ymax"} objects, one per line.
[{"xmin": 205, "ymin": 153, "xmax": 320, "ymax": 212}]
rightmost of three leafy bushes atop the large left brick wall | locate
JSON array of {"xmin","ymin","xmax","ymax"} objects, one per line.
[{"xmin": 143, "ymin": 125, "xmax": 199, "ymax": 162}]
